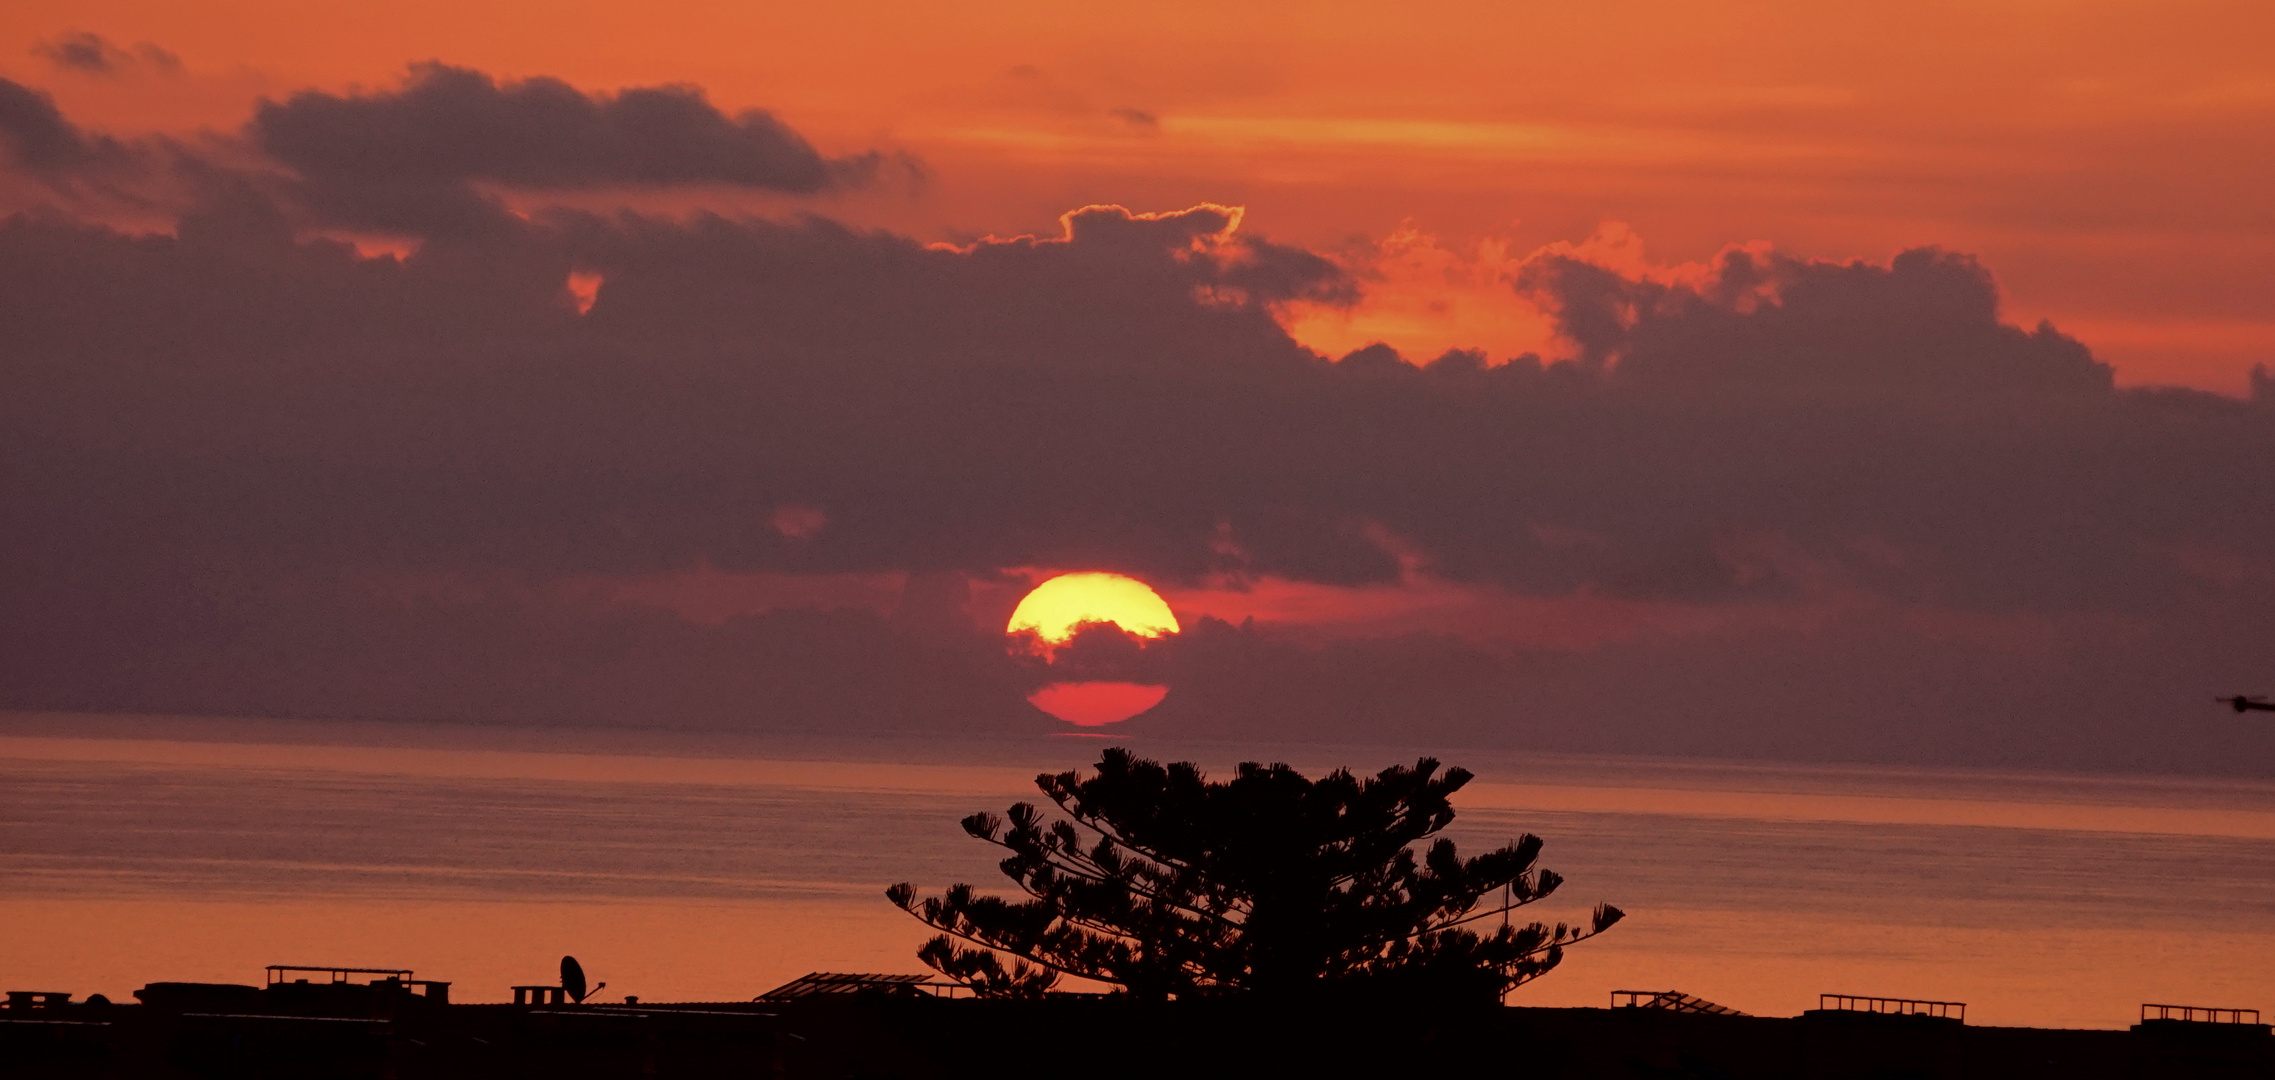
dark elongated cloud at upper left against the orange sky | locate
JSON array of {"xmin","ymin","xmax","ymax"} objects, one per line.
[{"xmin": 248, "ymin": 64, "xmax": 883, "ymax": 232}]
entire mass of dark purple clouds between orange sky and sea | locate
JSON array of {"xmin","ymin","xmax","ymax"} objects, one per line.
[{"xmin": 0, "ymin": 68, "xmax": 2275, "ymax": 773}]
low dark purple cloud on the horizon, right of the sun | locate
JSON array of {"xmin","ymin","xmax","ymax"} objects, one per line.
[{"xmin": 1146, "ymin": 605, "xmax": 2275, "ymax": 775}]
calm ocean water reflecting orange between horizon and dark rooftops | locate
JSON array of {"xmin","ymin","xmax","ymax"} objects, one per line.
[{"xmin": 0, "ymin": 714, "xmax": 2275, "ymax": 1028}]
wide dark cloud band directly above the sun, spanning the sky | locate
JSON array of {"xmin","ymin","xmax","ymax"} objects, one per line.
[{"xmin": 0, "ymin": 180, "xmax": 2270, "ymax": 605}]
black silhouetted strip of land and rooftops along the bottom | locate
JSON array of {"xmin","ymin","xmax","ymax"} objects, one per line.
[{"xmin": 0, "ymin": 996, "xmax": 2275, "ymax": 1080}]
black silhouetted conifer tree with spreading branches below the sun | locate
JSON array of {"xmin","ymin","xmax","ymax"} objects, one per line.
[{"xmin": 885, "ymin": 748, "xmax": 1622, "ymax": 1000}]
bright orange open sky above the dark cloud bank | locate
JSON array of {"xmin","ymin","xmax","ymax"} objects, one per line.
[{"xmin": 0, "ymin": 0, "xmax": 2275, "ymax": 393}]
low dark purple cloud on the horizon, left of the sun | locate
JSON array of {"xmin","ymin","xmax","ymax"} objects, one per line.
[{"xmin": 7, "ymin": 566, "xmax": 1053, "ymax": 734}]
